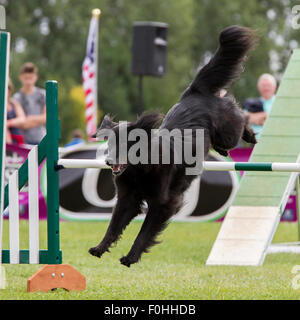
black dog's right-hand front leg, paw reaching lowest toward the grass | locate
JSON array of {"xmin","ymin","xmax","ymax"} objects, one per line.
[{"xmin": 120, "ymin": 196, "xmax": 182, "ymax": 267}]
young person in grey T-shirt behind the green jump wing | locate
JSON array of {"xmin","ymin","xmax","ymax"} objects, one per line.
[{"xmin": 14, "ymin": 62, "xmax": 46, "ymax": 144}]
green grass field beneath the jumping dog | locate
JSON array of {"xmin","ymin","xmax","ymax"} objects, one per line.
[{"xmin": 0, "ymin": 221, "xmax": 300, "ymax": 300}]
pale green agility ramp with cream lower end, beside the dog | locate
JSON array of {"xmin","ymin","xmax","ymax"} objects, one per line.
[{"xmin": 206, "ymin": 49, "xmax": 300, "ymax": 266}]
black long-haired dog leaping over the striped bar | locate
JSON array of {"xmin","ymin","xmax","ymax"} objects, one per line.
[{"xmin": 89, "ymin": 26, "xmax": 256, "ymax": 267}]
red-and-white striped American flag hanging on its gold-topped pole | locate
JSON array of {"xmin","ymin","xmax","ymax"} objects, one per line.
[{"xmin": 82, "ymin": 9, "xmax": 100, "ymax": 138}]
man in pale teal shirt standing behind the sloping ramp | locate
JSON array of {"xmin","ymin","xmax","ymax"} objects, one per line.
[{"xmin": 244, "ymin": 73, "xmax": 277, "ymax": 139}]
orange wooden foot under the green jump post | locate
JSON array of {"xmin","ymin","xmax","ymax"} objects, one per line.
[{"xmin": 27, "ymin": 264, "xmax": 86, "ymax": 292}]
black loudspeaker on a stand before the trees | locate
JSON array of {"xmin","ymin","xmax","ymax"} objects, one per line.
[{"xmin": 131, "ymin": 22, "xmax": 168, "ymax": 77}]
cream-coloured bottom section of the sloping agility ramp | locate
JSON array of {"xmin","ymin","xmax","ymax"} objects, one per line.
[{"xmin": 206, "ymin": 207, "xmax": 280, "ymax": 265}]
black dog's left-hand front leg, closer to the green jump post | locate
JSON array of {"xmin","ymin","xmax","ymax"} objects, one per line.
[{"xmin": 89, "ymin": 194, "xmax": 142, "ymax": 258}]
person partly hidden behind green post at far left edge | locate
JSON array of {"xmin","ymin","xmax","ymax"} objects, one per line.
[{"xmin": 6, "ymin": 80, "xmax": 25, "ymax": 144}]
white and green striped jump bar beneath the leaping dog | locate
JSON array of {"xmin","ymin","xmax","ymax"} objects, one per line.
[{"xmin": 57, "ymin": 159, "xmax": 300, "ymax": 172}]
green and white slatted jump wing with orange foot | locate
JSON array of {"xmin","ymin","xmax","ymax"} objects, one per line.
[{"xmin": 0, "ymin": 32, "xmax": 85, "ymax": 292}]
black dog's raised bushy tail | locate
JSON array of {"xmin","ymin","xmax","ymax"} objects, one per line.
[{"xmin": 190, "ymin": 26, "xmax": 256, "ymax": 94}]
